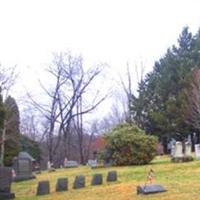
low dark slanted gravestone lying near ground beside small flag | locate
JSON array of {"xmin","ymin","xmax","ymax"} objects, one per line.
[{"xmin": 137, "ymin": 185, "xmax": 167, "ymax": 194}]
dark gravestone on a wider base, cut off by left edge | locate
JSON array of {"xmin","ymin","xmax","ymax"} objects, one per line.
[{"xmin": 0, "ymin": 167, "xmax": 15, "ymax": 200}]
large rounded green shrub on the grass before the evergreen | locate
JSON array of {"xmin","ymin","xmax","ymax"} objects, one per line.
[{"xmin": 104, "ymin": 124, "xmax": 158, "ymax": 165}]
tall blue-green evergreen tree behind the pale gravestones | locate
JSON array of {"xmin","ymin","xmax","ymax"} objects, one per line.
[{"xmin": 131, "ymin": 27, "xmax": 200, "ymax": 149}]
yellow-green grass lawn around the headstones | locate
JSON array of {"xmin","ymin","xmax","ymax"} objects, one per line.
[{"xmin": 12, "ymin": 156, "xmax": 200, "ymax": 200}]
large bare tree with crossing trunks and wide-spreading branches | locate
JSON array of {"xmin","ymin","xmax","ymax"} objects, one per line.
[{"xmin": 29, "ymin": 53, "xmax": 106, "ymax": 161}]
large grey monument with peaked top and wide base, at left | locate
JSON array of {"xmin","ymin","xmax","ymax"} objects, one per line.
[{"xmin": 13, "ymin": 152, "xmax": 35, "ymax": 181}]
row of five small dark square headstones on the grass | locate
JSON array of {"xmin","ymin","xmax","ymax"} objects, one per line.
[{"xmin": 37, "ymin": 171, "xmax": 117, "ymax": 195}]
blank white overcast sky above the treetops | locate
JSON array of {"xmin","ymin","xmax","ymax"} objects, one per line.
[{"xmin": 0, "ymin": 0, "xmax": 200, "ymax": 116}]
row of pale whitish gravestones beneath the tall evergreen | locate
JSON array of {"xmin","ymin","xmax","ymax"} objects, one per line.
[{"xmin": 171, "ymin": 142, "xmax": 200, "ymax": 159}]
